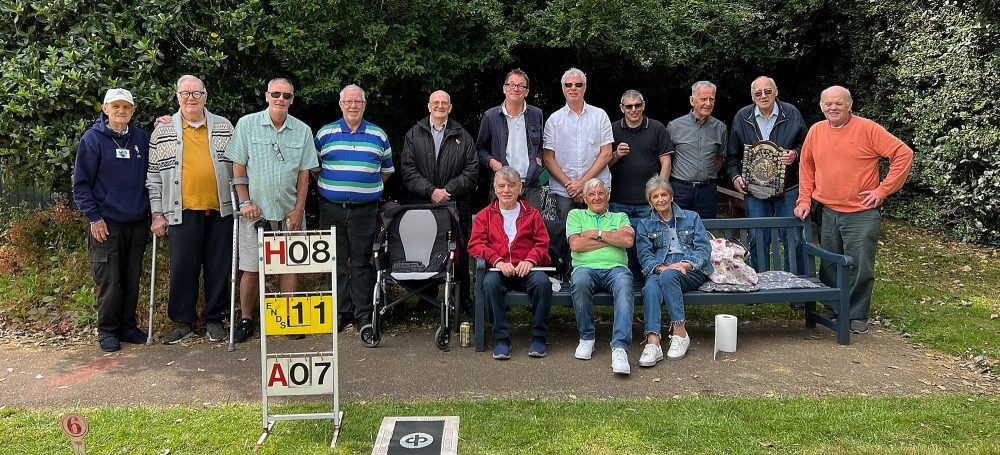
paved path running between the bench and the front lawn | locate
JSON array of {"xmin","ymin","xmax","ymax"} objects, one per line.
[{"xmin": 0, "ymin": 324, "xmax": 1000, "ymax": 407}]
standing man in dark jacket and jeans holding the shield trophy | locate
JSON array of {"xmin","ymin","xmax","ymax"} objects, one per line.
[{"xmin": 726, "ymin": 76, "xmax": 807, "ymax": 270}]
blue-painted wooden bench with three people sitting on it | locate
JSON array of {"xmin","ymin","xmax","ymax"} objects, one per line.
[{"xmin": 473, "ymin": 217, "xmax": 854, "ymax": 351}]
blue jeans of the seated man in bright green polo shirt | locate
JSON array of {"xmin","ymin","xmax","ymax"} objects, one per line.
[{"xmin": 571, "ymin": 266, "xmax": 634, "ymax": 349}]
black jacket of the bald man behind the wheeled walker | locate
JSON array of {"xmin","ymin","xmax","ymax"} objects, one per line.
[{"xmin": 400, "ymin": 117, "xmax": 479, "ymax": 207}]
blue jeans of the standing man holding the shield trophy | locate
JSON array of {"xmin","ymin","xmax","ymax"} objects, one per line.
[{"xmin": 743, "ymin": 187, "xmax": 805, "ymax": 272}]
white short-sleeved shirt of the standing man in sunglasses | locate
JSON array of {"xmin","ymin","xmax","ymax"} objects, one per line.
[{"xmin": 542, "ymin": 104, "xmax": 615, "ymax": 196}]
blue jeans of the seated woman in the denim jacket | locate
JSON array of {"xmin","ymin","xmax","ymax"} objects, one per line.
[{"xmin": 642, "ymin": 269, "xmax": 707, "ymax": 336}]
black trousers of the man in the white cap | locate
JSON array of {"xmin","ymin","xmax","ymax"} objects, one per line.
[{"xmin": 87, "ymin": 219, "xmax": 149, "ymax": 335}]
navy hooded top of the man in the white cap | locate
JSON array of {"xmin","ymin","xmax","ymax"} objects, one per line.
[{"xmin": 73, "ymin": 113, "xmax": 149, "ymax": 223}]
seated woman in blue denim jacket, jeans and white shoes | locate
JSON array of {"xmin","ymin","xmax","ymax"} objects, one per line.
[{"xmin": 636, "ymin": 177, "xmax": 712, "ymax": 367}]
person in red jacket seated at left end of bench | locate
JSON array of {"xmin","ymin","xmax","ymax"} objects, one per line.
[{"xmin": 469, "ymin": 166, "xmax": 552, "ymax": 360}]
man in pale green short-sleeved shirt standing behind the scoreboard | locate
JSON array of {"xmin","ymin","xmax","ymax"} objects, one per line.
[{"xmin": 226, "ymin": 78, "xmax": 319, "ymax": 343}]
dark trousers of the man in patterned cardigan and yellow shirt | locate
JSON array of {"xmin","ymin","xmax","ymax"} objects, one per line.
[{"xmin": 167, "ymin": 210, "xmax": 233, "ymax": 324}]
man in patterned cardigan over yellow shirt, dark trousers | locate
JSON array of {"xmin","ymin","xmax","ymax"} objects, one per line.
[{"xmin": 146, "ymin": 75, "xmax": 233, "ymax": 344}]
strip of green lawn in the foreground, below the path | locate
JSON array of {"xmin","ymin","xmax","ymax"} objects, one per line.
[{"xmin": 0, "ymin": 395, "xmax": 1000, "ymax": 455}]
